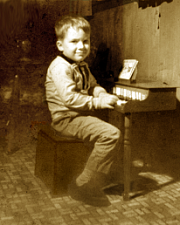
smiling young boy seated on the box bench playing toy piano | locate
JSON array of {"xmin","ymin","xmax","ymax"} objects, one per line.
[{"xmin": 45, "ymin": 16, "xmax": 123, "ymax": 206}]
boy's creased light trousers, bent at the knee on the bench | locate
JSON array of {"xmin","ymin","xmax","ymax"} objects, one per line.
[{"xmin": 52, "ymin": 116, "xmax": 121, "ymax": 175}]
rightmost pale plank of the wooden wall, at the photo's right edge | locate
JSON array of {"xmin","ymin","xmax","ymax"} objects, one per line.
[{"xmin": 158, "ymin": 1, "xmax": 180, "ymax": 98}]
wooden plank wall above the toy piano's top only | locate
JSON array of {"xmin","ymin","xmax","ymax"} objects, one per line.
[{"xmin": 91, "ymin": 0, "xmax": 180, "ymax": 86}]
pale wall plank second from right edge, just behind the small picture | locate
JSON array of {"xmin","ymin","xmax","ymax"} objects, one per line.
[{"xmin": 133, "ymin": 7, "xmax": 159, "ymax": 80}]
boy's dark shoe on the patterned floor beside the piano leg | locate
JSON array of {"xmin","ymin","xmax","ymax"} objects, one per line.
[{"xmin": 68, "ymin": 180, "xmax": 111, "ymax": 207}]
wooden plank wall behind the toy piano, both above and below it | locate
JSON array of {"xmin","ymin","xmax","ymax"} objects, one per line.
[{"xmin": 91, "ymin": 0, "xmax": 180, "ymax": 157}]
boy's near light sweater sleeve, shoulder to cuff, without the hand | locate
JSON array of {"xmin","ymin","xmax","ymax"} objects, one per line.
[{"xmin": 51, "ymin": 61, "xmax": 93, "ymax": 110}]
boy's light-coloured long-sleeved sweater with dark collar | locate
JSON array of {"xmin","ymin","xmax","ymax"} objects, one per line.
[{"xmin": 45, "ymin": 56, "xmax": 107, "ymax": 121}]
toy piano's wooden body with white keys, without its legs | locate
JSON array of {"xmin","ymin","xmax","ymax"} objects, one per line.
[{"xmin": 112, "ymin": 81, "xmax": 176, "ymax": 113}]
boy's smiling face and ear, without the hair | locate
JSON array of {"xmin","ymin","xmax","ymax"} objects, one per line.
[{"xmin": 57, "ymin": 27, "xmax": 90, "ymax": 62}]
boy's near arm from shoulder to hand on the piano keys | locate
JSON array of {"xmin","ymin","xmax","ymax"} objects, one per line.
[{"xmin": 51, "ymin": 64, "xmax": 117, "ymax": 110}]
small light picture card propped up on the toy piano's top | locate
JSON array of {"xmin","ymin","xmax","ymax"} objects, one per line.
[{"xmin": 118, "ymin": 59, "xmax": 138, "ymax": 83}]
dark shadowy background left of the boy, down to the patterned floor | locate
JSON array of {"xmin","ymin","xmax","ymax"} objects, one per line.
[{"xmin": 0, "ymin": 0, "xmax": 69, "ymax": 143}]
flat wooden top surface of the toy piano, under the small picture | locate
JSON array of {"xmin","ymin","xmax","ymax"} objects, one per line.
[{"xmin": 115, "ymin": 80, "xmax": 177, "ymax": 90}]
